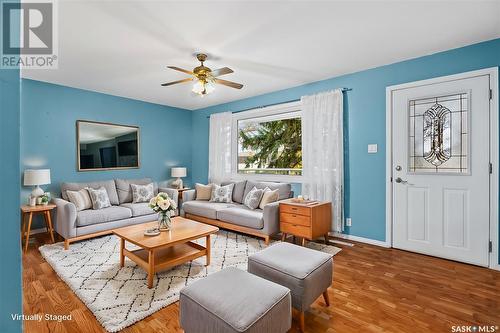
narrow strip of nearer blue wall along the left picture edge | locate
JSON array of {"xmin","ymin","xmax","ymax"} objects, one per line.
[{"xmin": 0, "ymin": 0, "xmax": 22, "ymax": 333}]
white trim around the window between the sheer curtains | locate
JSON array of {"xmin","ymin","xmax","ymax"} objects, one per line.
[{"xmin": 231, "ymin": 101, "xmax": 303, "ymax": 183}]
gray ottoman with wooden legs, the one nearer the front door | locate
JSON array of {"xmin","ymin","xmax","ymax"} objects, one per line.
[{"xmin": 248, "ymin": 242, "xmax": 333, "ymax": 331}]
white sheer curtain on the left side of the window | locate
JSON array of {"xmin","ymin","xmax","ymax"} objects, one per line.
[{"xmin": 208, "ymin": 112, "xmax": 232, "ymax": 184}]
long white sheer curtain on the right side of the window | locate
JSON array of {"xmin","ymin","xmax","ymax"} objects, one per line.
[{"xmin": 301, "ymin": 89, "xmax": 344, "ymax": 232}]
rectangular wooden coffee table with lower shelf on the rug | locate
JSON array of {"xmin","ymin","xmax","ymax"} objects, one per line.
[{"xmin": 113, "ymin": 216, "xmax": 219, "ymax": 288}]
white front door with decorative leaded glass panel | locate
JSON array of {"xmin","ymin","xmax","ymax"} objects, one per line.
[{"xmin": 392, "ymin": 75, "xmax": 490, "ymax": 266}]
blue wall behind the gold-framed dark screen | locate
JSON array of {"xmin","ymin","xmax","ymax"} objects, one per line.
[{"xmin": 21, "ymin": 79, "xmax": 192, "ymax": 226}]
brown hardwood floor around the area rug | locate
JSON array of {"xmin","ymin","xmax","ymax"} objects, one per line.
[{"xmin": 23, "ymin": 234, "xmax": 500, "ymax": 333}]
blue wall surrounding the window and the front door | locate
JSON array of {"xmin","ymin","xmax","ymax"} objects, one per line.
[{"xmin": 192, "ymin": 39, "xmax": 500, "ymax": 241}]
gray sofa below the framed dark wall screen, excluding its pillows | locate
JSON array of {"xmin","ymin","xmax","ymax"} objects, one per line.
[{"xmin": 53, "ymin": 178, "xmax": 178, "ymax": 249}]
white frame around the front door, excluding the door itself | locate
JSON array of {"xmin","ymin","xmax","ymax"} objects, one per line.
[{"xmin": 385, "ymin": 67, "xmax": 500, "ymax": 270}]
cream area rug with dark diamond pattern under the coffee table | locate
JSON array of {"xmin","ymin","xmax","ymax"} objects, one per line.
[{"xmin": 39, "ymin": 231, "xmax": 340, "ymax": 332}]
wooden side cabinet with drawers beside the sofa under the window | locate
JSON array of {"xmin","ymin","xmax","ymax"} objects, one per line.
[{"xmin": 280, "ymin": 200, "xmax": 332, "ymax": 246}]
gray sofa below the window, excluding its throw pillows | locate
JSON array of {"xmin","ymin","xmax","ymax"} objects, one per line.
[{"xmin": 182, "ymin": 180, "xmax": 293, "ymax": 244}]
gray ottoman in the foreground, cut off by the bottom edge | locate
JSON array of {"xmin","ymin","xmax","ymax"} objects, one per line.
[{"xmin": 180, "ymin": 268, "xmax": 292, "ymax": 333}]
